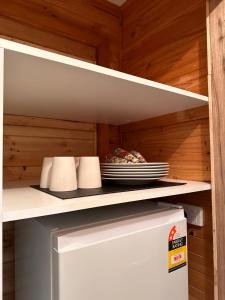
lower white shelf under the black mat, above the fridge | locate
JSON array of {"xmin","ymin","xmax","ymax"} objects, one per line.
[{"xmin": 3, "ymin": 179, "xmax": 211, "ymax": 222}]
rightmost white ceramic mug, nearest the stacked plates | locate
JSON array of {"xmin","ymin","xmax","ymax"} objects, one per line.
[{"xmin": 78, "ymin": 156, "xmax": 102, "ymax": 189}]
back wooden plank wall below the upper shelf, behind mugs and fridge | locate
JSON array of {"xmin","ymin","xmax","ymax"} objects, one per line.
[{"xmin": 3, "ymin": 115, "xmax": 96, "ymax": 300}]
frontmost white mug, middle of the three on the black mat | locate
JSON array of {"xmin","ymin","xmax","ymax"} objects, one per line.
[{"xmin": 49, "ymin": 157, "xmax": 77, "ymax": 192}]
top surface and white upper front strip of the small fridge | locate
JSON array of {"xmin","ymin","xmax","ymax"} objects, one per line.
[{"xmin": 48, "ymin": 203, "xmax": 184, "ymax": 253}]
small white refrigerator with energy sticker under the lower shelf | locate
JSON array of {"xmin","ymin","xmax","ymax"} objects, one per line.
[{"xmin": 16, "ymin": 201, "xmax": 188, "ymax": 300}]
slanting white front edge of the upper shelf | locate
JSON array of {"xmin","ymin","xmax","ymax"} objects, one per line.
[{"xmin": 0, "ymin": 39, "xmax": 208, "ymax": 102}]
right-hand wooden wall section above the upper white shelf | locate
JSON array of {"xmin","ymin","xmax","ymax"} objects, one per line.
[{"xmin": 122, "ymin": 0, "xmax": 207, "ymax": 95}]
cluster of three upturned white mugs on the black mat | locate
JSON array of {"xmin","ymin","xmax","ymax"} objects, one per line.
[{"xmin": 40, "ymin": 156, "xmax": 102, "ymax": 192}]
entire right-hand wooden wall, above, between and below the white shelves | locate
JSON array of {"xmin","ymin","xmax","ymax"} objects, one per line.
[{"xmin": 120, "ymin": 0, "xmax": 214, "ymax": 300}]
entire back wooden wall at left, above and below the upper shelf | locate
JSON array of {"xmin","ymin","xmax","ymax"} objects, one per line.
[{"xmin": 0, "ymin": 0, "xmax": 121, "ymax": 300}]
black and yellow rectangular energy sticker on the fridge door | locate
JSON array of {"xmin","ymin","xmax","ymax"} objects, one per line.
[{"xmin": 168, "ymin": 236, "xmax": 187, "ymax": 273}]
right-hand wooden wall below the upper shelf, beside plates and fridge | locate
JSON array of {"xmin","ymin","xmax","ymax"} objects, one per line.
[{"xmin": 120, "ymin": 106, "xmax": 214, "ymax": 300}]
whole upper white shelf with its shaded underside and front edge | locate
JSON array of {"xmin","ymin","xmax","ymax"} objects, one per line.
[{"xmin": 0, "ymin": 39, "xmax": 208, "ymax": 125}]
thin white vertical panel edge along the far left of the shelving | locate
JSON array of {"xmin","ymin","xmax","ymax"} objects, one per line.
[{"xmin": 0, "ymin": 48, "xmax": 4, "ymax": 300}]
